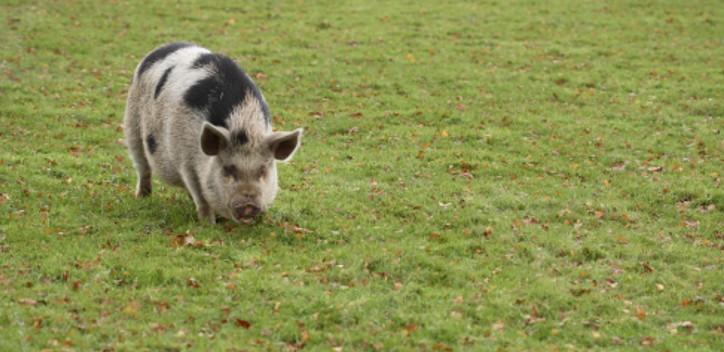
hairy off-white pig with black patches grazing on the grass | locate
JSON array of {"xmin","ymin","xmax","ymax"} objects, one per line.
[{"xmin": 124, "ymin": 43, "xmax": 303, "ymax": 224}]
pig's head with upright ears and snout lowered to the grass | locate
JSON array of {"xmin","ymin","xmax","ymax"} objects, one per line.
[{"xmin": 201, "ymin": 123, "xmax": 302, "ymax": 224}]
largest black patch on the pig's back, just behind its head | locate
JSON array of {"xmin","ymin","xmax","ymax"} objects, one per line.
[{"xmin": 184, "ymin": 54, "xmax": 271, "ymax": 128}]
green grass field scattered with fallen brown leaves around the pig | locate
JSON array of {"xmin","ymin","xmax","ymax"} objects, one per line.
[{"xmin": 0, "ymin": 0, "xmax": 724, "ymax": 351}]
